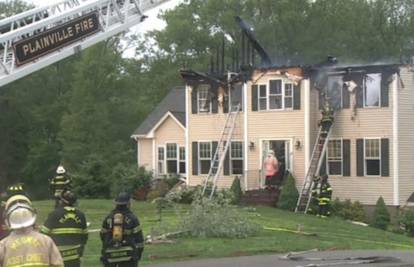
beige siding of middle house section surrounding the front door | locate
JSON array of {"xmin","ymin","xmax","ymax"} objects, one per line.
[{"xmin": 247, "ymin": 71, "xmax": 305, "ymax": 189}]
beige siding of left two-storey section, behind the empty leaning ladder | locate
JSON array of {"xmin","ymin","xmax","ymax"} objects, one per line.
[{"xmin": 188, "ymin": 86, "xmax": 243, "ymax": 187}]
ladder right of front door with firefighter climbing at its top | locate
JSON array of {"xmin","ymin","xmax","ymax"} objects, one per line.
[{"xmin": 295, "ymin": 118, "xmax": 333, "ymax": 214}]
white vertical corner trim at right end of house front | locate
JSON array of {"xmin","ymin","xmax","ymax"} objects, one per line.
[{"xmin": 392, "ymin": 74, "xmax": 400, "ymax": 206}]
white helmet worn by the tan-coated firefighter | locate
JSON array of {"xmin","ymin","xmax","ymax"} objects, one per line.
[{"xmin": 5, "ymin": 195, "xmax": 36, "ymax": 230}]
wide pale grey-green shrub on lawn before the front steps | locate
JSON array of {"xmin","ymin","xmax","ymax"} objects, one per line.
[{"xmin": 181, "ymin": 193, "xmax": 260, "ymax": 238}]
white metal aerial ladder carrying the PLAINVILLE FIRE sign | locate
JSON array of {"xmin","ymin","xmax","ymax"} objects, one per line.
[{"xmin": 0, "ymin": 0, "xmax": 169, "ymax": 87}]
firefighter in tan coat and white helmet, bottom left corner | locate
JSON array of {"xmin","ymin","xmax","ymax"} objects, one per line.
[{"xmin": 0, "ymin": 195, "xmax": 63, "ymax": 267}]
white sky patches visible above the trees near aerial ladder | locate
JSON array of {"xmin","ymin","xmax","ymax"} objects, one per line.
[{"xmin": 24, "ymin": 0, "xmax": 182, "ymax": 57}]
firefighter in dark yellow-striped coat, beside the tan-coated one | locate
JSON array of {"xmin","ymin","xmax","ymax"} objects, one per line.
[{"xmin": 40, "ymin": 190, "xmax": 88, "ymax": 267}]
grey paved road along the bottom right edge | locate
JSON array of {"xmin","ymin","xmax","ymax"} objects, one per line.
[{"xmin": 148, "ymin": 251, "xmax": 414, "ymax": 267}]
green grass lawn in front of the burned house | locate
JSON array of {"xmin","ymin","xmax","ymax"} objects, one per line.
[{"xmin": 35, "ymin": 200, "xmax": 414, "ymax": 267}]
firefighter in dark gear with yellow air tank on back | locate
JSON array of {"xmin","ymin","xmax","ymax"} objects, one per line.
[{"xmin": 100, "ymin": 192, "xmax": 144, "ymax": 267}]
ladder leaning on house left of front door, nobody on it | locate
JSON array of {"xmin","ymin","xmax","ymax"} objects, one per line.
[{"xmin": 202, "ymin": 104, "xmax": 240, "ymax": 198}]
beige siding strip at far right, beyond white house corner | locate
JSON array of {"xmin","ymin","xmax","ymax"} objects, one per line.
[{"xmin": 398, "ymin": 67, "xmax": 414, "ymax": 205}]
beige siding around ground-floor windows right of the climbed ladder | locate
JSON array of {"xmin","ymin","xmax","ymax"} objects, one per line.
[{"xmin": 322, "ymin": 81, "xmax": 393, "ymax": 205}]
